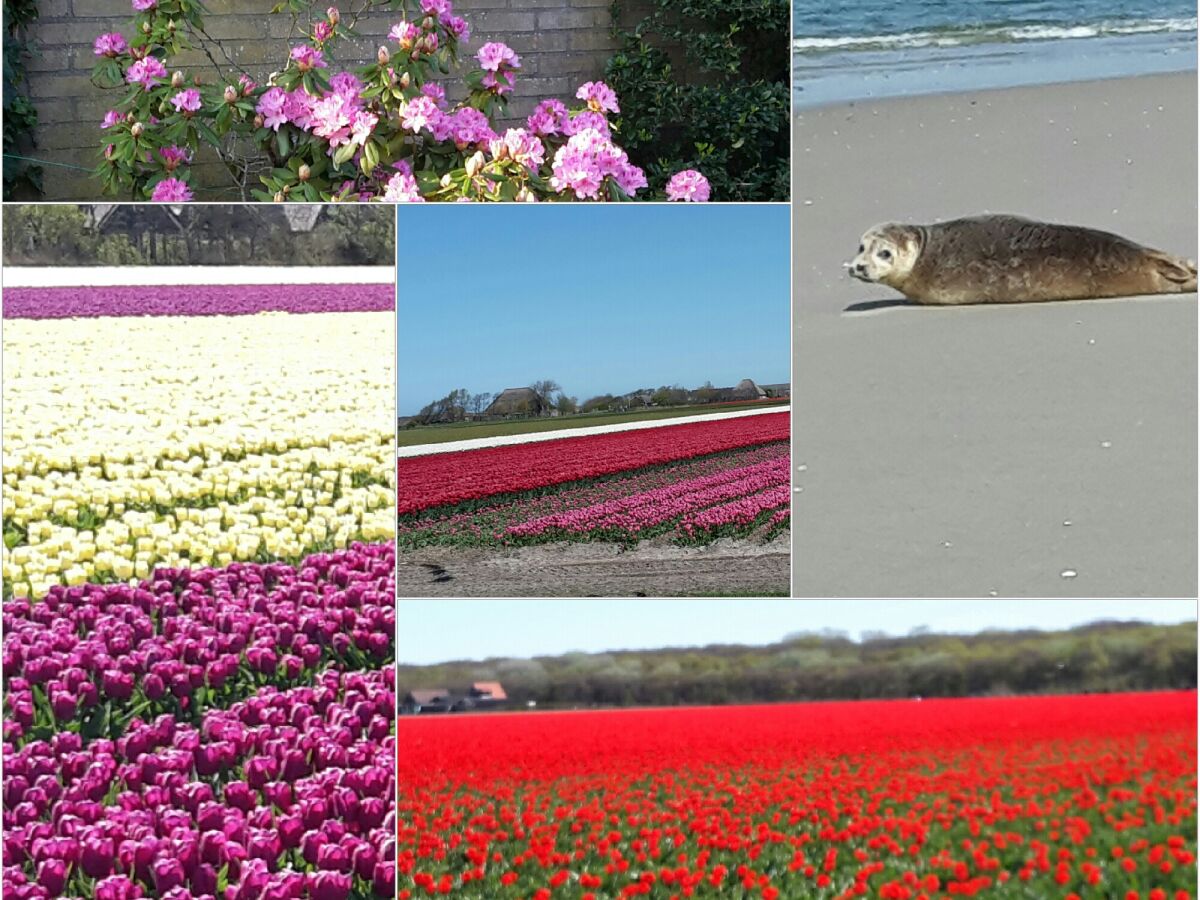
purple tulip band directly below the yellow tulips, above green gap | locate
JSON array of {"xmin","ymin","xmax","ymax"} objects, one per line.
[{"xmin": 4, "ymin": 544, "xmax": 396, "ymax": 746}]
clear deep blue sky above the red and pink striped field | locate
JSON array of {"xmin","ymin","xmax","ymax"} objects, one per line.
[{"xmin": 397, "ymin": 204, "xmax": 791, "ymax": 415}]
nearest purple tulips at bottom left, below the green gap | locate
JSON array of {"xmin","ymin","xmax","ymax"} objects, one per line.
[{"xmin": 2, "ymin": 667, "xmax": 396, "ymax": 900}]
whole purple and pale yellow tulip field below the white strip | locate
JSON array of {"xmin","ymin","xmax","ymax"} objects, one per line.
[{"xmin": 2, "ymin": 278, "xmax": 396, "ymax": 900}]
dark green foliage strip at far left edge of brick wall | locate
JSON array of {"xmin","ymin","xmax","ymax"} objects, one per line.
[{"xmin": 4, "ymin": 0, "xmax": 43, "ymax": 200}]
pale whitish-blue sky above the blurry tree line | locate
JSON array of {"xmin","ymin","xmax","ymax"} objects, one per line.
[{"xmin": 397, "ymin": 599, "xmax": 1196, "ymax": 665}]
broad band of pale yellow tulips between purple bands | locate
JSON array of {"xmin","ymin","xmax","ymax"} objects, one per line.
[{"xmin": 4, "ymin": 309, "xmax": 396, "ymax": 596}]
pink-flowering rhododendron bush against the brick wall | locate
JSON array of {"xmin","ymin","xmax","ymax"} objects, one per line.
[{"xmin": 92, "ymin": 0, "xmax": 708, "ymax": 203}]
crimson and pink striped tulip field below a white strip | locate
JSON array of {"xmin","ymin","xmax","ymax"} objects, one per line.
[{"xmin": 397, "ymin": 413, "xmax": 791, "ymax": 548}]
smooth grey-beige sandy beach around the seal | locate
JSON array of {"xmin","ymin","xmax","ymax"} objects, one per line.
[{"xmin": 792, "ymin": 72, "xmax": 1196, "ymax": 598}]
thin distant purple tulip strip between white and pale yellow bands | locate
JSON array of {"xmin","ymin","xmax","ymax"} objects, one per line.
[{"xmin": 4, "ymin": 284, "xmax": 396, "ymax": 319}]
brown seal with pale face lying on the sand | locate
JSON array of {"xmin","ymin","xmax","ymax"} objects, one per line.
[{"xmin": 846, "ymin": 216, "xmax": 1196, "ymax": 306}]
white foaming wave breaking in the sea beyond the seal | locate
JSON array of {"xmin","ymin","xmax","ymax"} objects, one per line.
[{"xmin": 792, "ymin": 17, "xmax": 1196, "ymax": 53}]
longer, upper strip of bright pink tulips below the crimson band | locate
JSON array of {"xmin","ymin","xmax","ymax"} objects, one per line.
[{"xmin": 508, "ymin": 456, "xmax": 790, "ymax": 538}]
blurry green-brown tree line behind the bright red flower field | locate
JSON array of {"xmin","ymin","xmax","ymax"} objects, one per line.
[{"xmin": 397, "ymin": 622, "xmax": 1196, "ymax": 708}]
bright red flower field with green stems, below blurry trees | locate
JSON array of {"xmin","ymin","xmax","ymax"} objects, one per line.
[{"xmin": 397, "ymin": 691, "xmax": 1196, "ymax": 900}]
